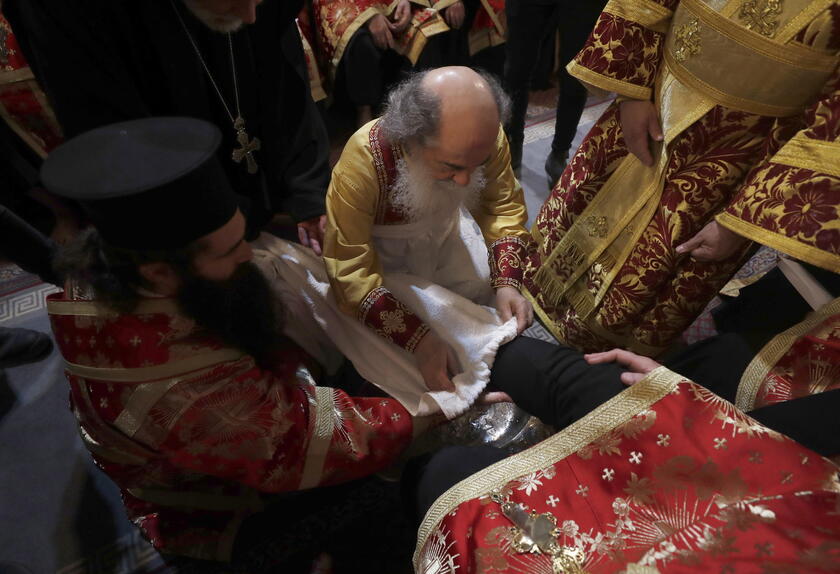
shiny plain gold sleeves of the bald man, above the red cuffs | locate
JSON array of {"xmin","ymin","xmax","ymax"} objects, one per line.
[{"xmin": 324, "ymin": 122, "xmax": 528, "ymax": 317}]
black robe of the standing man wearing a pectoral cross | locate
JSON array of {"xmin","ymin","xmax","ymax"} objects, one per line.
[{"xmin": 3, "ymin": 0, "xmax": 330, "ymax": 235}]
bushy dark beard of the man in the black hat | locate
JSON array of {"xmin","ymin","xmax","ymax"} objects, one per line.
[{"xmin": 177, "ymin": 261, "xmax": 283, "ymax": 366}]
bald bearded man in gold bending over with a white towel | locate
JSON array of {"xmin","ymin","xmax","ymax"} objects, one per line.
[{"xmin": 316, "ymin": 67, "xmax": 533, "ymax": 414}]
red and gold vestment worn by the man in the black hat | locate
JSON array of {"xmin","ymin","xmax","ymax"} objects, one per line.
[{"xmin": 48, "ymin": 294, "xmax": 412, "ymax": 560}]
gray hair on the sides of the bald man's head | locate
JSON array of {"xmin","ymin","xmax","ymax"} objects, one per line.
[{"xmin": 381, "ymin": 69, "xmax": 510, "ymax": 145}]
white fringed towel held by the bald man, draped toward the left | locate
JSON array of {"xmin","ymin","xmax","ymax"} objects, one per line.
[{"xmin": 254, "ymin": 234, "xmax": 516, "ymax": 418}]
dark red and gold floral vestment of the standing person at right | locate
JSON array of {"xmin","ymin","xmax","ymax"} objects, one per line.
[{"xmin": 525, "ymin": 0, "xmax": 840, "ymax": 355}]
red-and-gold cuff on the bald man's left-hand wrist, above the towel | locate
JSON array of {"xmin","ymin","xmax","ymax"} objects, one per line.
[{"xmin": 359, "ymin": 287, "xmax": 429, "ymax": 352}]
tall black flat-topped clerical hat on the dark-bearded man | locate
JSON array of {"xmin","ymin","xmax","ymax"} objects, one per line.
[{"xmin": 41, "ymin": 117, "xmax": 238, "ymax": 250}]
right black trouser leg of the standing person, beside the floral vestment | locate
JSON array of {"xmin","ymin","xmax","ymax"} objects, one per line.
[{"xmin": 551, "ymin": 0, "xmax": 605, "ymax": 155}]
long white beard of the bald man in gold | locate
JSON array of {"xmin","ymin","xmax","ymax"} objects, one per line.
[{"xmin": 391, "ymin": 159, "xmax": 487, "ymax": 221}]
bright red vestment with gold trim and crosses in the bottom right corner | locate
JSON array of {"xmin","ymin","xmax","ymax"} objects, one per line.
[{"xmin": 414, "ymin": 367, "xmax": 840, "ymax": 574}]
